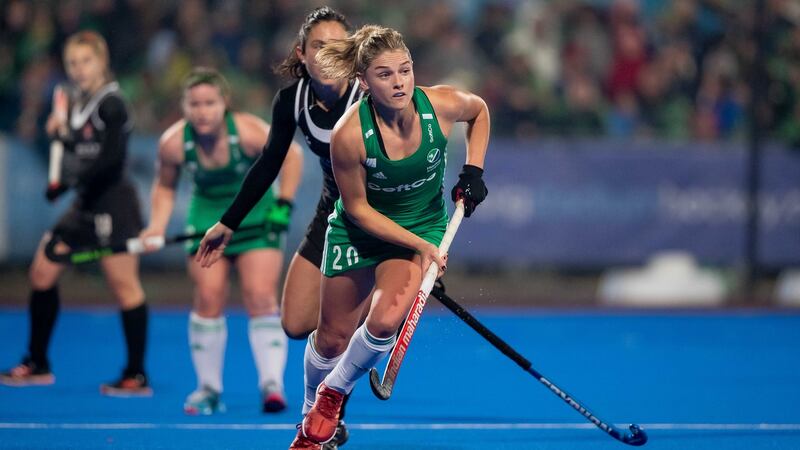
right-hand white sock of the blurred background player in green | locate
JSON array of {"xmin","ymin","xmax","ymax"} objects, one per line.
[{"xmin": 248, "ymin": 314, "xmax": 288, "ymax": 392}]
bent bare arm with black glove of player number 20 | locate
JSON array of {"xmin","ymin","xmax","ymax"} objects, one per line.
[{"xmin": 424, "ymin": 85, "xmax": 490, "ymax": 217}]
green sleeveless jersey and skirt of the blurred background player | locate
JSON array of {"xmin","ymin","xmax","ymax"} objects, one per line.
[{"xmin": 183, "ymin": 113, "xmax": 282, "ymax": 255}]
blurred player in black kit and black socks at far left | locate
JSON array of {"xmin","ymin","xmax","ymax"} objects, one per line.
[{"xmin": 0, "ymin": 31, "xmax": 152, "ymax": 396}]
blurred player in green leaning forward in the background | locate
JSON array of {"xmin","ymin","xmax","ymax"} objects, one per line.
[{"xmin": 141, "ymin": 68, "xmax": 302, "ymax": 414}]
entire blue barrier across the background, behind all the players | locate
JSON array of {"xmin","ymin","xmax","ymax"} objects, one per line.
[{"xmin": 0, "ymin": 137, "xmax": 800, "ymax": 267}]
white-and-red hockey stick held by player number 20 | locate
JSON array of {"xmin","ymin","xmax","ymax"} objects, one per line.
[{"xmin": 369, "ymin": 200, "xmax": 464, "ymax": 400}]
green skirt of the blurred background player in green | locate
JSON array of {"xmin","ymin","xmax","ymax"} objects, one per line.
[{"xmin": 184, "ymin": 193, "xmax": 286, "ymax": 256}]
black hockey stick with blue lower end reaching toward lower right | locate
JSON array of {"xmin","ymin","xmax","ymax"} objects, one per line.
[{"xmin": 431, "ymin": 283, "xmax": 647, "ymax": 446}]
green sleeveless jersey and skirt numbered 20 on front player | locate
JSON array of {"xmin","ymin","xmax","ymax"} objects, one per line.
[{"xmin": 321, "ymin": 88, "xmax": 447, "ymax": 276}]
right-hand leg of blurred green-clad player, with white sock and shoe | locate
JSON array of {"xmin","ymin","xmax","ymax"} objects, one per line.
[{"xmin": 236, "ymin": 248, "xmax": 287, "ymax": 412}]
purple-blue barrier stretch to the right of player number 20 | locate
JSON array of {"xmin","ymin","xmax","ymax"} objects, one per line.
[{"xmin": 456, "ymin": 142, "xmax": 800, "ymax": 267}]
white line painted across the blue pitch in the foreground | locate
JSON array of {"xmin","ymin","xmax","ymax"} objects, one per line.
[{"xmin": 0, "ymin": 422, "xmax": 800, "ymax": 431}]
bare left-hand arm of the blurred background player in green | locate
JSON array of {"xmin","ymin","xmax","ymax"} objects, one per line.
[{"xmin": 139, "ymin": 120, "xmax": 186, "ymax": 250}]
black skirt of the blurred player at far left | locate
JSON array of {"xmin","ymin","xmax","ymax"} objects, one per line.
[{"xmin": 53, "ymin": 181, "xmax": 144, "ymax": 248}]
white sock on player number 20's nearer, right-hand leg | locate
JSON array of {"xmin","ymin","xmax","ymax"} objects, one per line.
[{"xmin": 325, "ymin": 324, "xmax": 396, "ymax": 394}]
